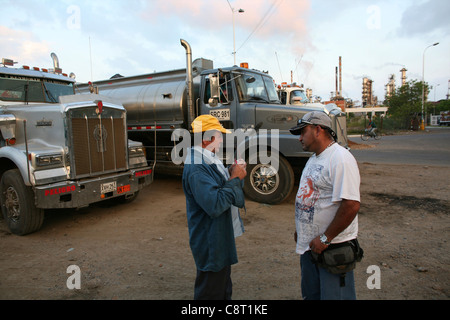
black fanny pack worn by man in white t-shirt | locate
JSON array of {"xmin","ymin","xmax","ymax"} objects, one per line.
[{"xmin": 311, "ymin": 239, "xmax": 364, "ymax": 285}]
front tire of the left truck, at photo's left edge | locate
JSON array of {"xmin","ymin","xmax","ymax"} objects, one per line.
[{"xmin": 0, "ymin": 169, "xmax": 44, "ymax": 236}]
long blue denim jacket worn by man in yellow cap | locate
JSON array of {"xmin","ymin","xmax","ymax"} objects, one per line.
[{"xmin": 183, "ymin": 148, "xmax": 245, "ymax": 272}]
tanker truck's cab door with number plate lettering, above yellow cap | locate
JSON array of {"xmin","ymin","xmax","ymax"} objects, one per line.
[{"xmin": 199, "ymin": 72, "xmax": 237, "ymax": 129}]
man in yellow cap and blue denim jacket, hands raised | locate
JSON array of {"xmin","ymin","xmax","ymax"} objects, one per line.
[{"xmin": 183, "ymin": 115, "xmax": 247, "ymax": 300}]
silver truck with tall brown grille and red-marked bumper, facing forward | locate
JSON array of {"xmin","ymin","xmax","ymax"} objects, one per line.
[{"xmin": 0, "ymin": 54, "xmax": 153, "ymax": 235}]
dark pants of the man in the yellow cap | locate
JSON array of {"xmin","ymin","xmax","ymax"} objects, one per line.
[{"xmin": 194, "ymin": 266, "xmax": 232, "ymax": 300}]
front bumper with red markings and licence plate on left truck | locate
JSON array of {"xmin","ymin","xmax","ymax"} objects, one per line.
[{"xmin": 34, "ymin": 167, "xmax": 153, "ymax": 209}]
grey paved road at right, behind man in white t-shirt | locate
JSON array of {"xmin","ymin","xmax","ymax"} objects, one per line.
[{"xmin": 349, "ymin": 127, "xmax": 450, "ymax": 167}]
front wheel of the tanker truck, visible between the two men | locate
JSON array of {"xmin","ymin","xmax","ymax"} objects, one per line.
[{"xmin": 244, "ymin": 156, "xmax": 294, "ymax": 204}]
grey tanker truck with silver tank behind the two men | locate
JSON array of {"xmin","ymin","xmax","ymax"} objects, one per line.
[{"xmin": 78, "ymin": 39, "xmax": 346, "ymax": 204}]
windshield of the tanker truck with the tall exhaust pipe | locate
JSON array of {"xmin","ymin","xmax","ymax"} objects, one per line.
[{"xmin": 236, "ymin": 73, "xmax": 279, "ymax": 103}]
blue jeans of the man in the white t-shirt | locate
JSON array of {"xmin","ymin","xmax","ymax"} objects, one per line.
[{"xmin": 300, "ymin": 251, "xmax": 356, "ymax": 300}]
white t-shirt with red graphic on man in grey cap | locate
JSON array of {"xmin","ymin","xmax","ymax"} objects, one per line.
[{"xmin": 295, "ymin": 143, "xmax": 360, "ymax": 254}]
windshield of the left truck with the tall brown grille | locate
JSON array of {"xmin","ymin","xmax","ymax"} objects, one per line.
[{"xmin": 0, "ymin": 76, "xmax": 74, "ymax": 103}]
